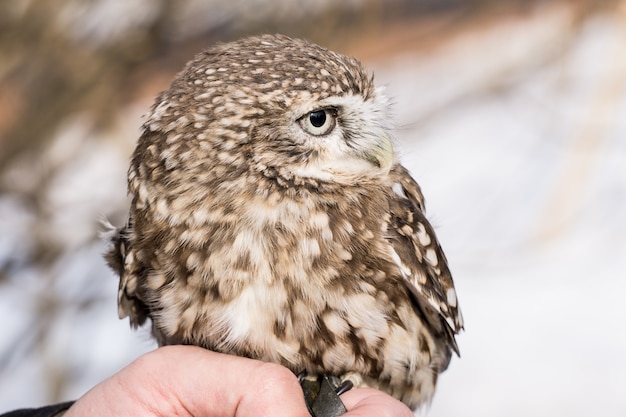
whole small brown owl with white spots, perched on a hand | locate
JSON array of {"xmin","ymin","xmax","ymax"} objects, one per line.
[{"xmin": 106, "ymin": 35, "xmax": 463, "ymax": 409}]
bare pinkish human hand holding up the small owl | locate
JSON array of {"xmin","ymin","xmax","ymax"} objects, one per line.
[{"xmin": 65, "ymin": 346, "xmax": 413, "ymax": 417}]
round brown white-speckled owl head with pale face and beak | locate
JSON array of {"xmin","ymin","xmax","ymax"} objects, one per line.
[{"xmin": 130, "ymin": 35, "xmax": 394, "ymax": 200}]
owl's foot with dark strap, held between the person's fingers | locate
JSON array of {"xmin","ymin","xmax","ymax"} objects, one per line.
[{"xmin": 298, "ymin": 374, "xmax": 353, "ymax": 417}]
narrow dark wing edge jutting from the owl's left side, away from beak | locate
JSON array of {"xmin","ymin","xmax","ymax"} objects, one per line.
[{"xmin": 100, "ymin": 219, "xmax": 148, "ymax": 328}]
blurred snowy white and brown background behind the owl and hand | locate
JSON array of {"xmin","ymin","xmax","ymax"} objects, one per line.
[{"xmin": 0, "ymin": 0, "xmax": 626, "ymax": 417}]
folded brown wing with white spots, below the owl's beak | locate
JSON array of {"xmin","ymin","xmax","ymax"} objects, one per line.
[{"xmin": 388, "ymin": 165, "xmax": 463, "ymax": 355}]
